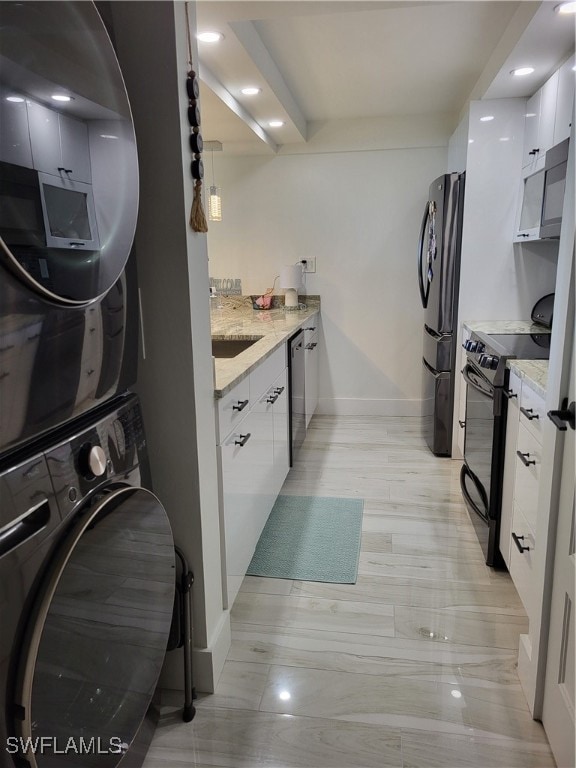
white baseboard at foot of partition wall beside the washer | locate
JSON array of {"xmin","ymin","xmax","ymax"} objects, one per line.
[{"xmin": 158, "ymin": 611, "xmax": 232, "ymax": 693}]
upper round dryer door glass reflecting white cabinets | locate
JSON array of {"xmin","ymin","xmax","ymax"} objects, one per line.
[{"xmin": 0, "ymin": 0, "xmax": 138, "ymax": 304}]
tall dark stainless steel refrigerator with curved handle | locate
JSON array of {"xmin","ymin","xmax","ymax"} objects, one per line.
[{"xmin": 418, "ymin": 173, "xmax": 465, "ymax": 456}]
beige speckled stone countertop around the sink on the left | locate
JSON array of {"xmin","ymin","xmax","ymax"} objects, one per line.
[{"xmin": 210, "ymin": 296, "xmax": 320, "ymax": 398}]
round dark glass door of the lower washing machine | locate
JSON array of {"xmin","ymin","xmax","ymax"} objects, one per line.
[{"xmin": 15, "ymin": 487, "xmax": 175, "ymax": 768}]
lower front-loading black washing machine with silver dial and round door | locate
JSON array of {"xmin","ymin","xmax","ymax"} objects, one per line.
[{"xmin": 0, "ymin": 395, "xmax": 175, "ymax": 768}]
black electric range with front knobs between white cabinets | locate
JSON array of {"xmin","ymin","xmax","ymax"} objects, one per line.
[{"xmin": 460, "ymin": 331, "xmax": 550, "ymax": 568}]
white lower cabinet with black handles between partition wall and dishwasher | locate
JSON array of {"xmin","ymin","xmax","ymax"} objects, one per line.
[{"xmin": 217, "ymin": 346, "xmax": 288, "ymax": 608}]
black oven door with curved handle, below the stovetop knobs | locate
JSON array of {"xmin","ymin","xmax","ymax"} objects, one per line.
[{"xmin": 460, "ymin": 363, "xmax": 494, "ymax": 522}]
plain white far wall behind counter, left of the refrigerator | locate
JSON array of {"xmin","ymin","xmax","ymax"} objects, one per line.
[{"xmin": 208, "ymin": 135, "xmax": 448, "ymax": 415}]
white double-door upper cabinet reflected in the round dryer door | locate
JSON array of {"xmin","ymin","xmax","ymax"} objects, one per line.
[{"xmin": 28, "ymin": 102, "xmax": 92, "ymax": 184}]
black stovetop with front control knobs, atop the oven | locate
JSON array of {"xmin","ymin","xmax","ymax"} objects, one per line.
[{"xmin": 464, "ymin": 329, "xmax": 550, "ymax": 387}]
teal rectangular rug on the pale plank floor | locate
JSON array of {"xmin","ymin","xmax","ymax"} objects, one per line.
[{"xmin": 247, "ymin": 496, "xmax": 364, "ymax": 584}]
